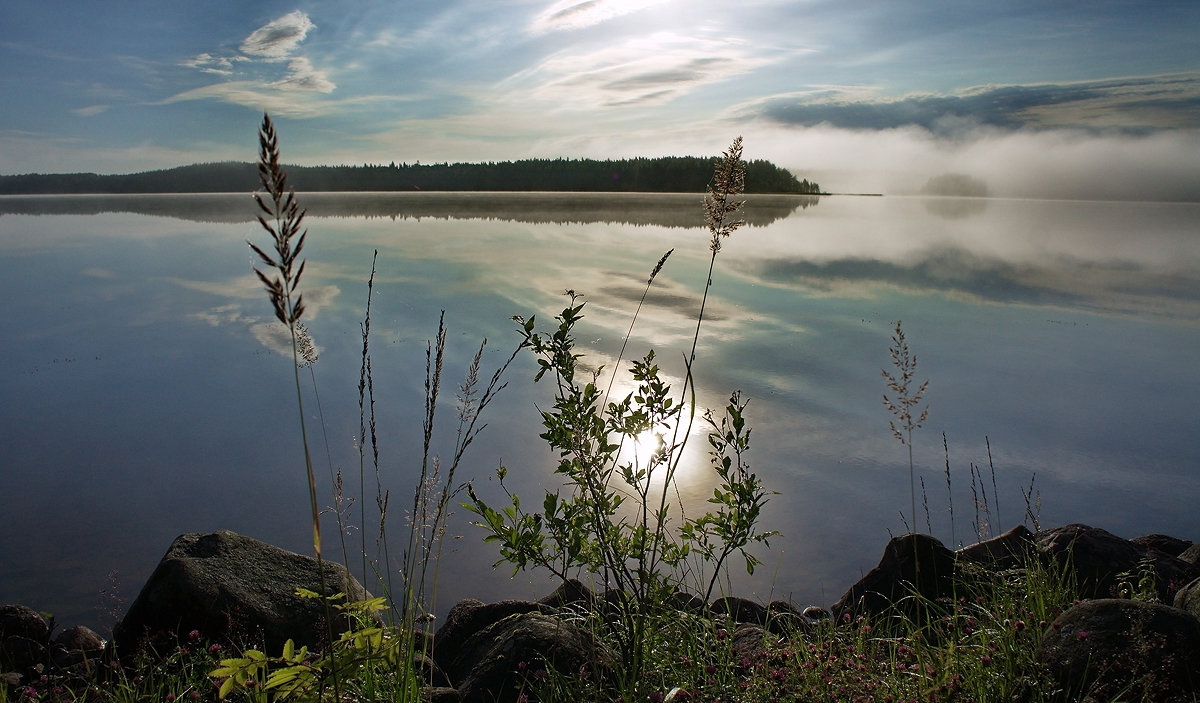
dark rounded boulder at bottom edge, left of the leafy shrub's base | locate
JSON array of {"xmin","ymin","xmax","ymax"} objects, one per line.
[{"xmin": 451, "ymin": 612, "xmax": 613, "ymax": 703}]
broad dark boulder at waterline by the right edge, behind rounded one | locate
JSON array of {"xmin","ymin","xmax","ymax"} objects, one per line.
[{"xmin": 1037, "ymin": 524, "xmax": 1200, "ymax": 602}]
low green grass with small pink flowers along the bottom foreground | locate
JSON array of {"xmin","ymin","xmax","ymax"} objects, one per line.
[{"xmin": 0, "ymin": 565, "xmax": 1094, "ymax": 703}]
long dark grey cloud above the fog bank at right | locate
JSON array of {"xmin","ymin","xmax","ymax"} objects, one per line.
[{"xmin": 746, "ymin": 73, "xmax": 1200, "ymax": 137}]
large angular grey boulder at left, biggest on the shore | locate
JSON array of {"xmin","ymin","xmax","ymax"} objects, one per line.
[{"xmin": 113, "ymin": 530, "xmax": 370, "ymax": 657}]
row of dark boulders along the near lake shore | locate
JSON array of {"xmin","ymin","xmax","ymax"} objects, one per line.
[{"xmin": 0, "ymin": 524, "xmax": 1200, "ymax": 703}]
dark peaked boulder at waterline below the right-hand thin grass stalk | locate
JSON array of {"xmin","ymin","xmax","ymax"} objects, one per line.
[{"xmin": 832, "ymin": 534, "xmax": 954, "ymax": 618}]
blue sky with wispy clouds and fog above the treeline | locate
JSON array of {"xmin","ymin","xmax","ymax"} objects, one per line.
[{"xmin": 0, "ymin": 0, "xmax": 1200, "ymax": 196}]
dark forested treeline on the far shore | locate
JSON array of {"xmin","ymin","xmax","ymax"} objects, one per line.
[{"xmin": 0, "ymin": 156, "xmax": 821, "ymax": 194}]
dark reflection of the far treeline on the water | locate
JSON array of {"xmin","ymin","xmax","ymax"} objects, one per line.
[{"xmin": 0, "ymin": 192, "xmax": 821, "ymax": 227}]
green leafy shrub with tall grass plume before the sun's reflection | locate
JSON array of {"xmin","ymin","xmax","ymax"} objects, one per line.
[{"xmin": 464, "ymin": 138, "xmax": 774, "ymax": 691}]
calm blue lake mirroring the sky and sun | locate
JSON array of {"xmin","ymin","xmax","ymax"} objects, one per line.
[{"xmin": 0, "ymin": 193, "xmax": 1200, "ymax": 631}]
